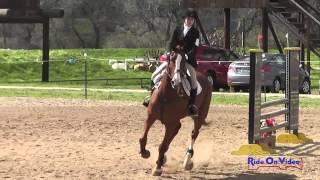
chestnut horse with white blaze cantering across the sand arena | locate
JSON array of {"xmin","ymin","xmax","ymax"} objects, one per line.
[{"xmin": 139, "ymin": 51, "xmax": 212, "ymax": 176}]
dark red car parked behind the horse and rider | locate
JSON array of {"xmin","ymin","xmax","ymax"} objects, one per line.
[{"xmin": 160, "ymin": 45, "xmax": 239, "ymax": 90}]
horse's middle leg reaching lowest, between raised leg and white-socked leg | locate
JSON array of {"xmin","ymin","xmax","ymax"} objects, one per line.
[{"xmin": 152, "ymin": 121, "xmax": 181, "ymax": 176}]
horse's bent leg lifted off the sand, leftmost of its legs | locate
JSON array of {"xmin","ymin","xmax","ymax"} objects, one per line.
[{"xmin": 139, "ymin": 115, "xmax": 156, "ymax": 158}]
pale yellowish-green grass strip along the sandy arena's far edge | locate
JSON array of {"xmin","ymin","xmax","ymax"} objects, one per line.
[{"xmin": 0, "ymin": 89, "xmax": 320, "ymax": 108}]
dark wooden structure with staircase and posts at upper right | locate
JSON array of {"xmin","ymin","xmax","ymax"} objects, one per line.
[{"xmin": 183, "ymin": 0, "xmax": 320, "ymax": 76}]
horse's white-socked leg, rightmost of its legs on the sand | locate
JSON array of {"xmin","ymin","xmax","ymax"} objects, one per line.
[{"xmin": 183, "ymin": 119, "xmax": 201, "ymax": 170}]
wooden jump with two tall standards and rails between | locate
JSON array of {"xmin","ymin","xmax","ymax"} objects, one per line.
[{"xmin": 248, "ymin": 48, "xmax": 300, "ymax": 144}]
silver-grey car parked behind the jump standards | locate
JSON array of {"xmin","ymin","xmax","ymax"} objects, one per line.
[{"xmin": 228, "ymin": 53, "xmax": 310, "ymax": 93}]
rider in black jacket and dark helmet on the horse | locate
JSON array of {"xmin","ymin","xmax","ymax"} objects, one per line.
[{"xmin": 143, "ymin": 9, "xmax": 199, "ymax": 115}]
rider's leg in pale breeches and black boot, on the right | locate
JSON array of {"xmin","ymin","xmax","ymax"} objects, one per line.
[{"xmin": 186, "ymin": 63, "xmax": 198, "ymax": 116}]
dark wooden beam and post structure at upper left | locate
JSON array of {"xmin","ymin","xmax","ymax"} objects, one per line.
[{"xmin": 0, "ymin": 0, "xmax": 64, "ymax": 82}]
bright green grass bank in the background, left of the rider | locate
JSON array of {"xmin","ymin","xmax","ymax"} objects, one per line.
[{"xmin": 0, "ymin": 48, "xmax": 157, "ymax": 85}]
